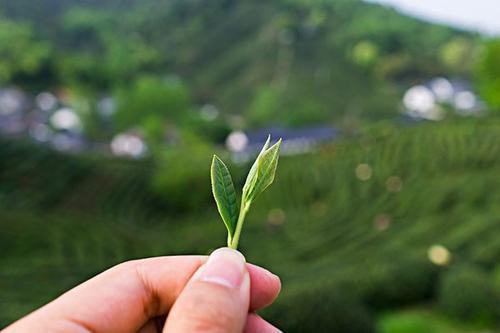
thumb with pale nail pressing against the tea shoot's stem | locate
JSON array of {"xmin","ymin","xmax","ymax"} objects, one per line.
[{"xmin": 163, "ymin": 248, "xmax": 250, "ymax": 333}]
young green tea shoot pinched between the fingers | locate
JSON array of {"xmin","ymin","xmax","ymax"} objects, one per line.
[{"xmin": 210, "ymin": 136, "xmax": 281, "ymax": 249}]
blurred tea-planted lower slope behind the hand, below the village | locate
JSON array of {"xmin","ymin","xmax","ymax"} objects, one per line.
[{"xmin": 0, "ymin": 118, "xmax": 500, "ymax": 332}]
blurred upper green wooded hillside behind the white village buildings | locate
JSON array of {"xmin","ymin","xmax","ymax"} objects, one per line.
[{"xmin": 0, "ymin": 0, "xmax": 477, "ymax": 126}]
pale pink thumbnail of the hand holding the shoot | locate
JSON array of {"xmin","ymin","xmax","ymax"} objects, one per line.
[{"xmin": 197, "ymin": 248, "xmax": 245, "ymax": 288}]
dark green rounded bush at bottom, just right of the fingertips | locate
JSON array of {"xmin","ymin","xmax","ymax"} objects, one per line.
[{"xmin": 268, "ymin": 288, "xmax": 375, "ymax": 333}]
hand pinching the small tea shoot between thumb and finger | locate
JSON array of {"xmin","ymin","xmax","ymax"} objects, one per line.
[{"xmin": 4, "ymin": 248, "xmax": 281, "ymax": 333}]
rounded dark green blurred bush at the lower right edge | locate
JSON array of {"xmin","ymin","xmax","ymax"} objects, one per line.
[{"xmin": 438, "ymin": 266, "xmax": 498, "ymax": 324}]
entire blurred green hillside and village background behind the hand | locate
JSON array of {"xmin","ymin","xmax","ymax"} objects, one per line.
[{"xmin": 0, "ymin": 0, "xmax": 500, "ymax": 333}]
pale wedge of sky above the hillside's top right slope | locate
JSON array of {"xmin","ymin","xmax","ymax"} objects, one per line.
[{"xmin": 368, "ymin": 0, "xmax": 500, "ymax": 36}]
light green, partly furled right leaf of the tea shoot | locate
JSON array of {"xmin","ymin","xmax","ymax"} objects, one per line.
[{"xmin": 244, "ymin": 139, "xmax": 281, "ymax": 205}]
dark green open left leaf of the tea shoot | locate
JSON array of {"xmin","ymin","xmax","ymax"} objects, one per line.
[{"xmin": 210, "ymin": 155, "xmax": 239, "ymax": 240}]
